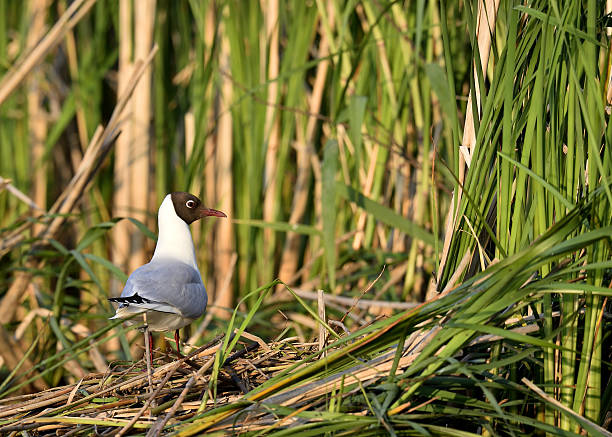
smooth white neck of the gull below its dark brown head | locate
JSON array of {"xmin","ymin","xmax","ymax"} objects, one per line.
[{"xmin": 151, "ymin": 194, "xmax": 198, "ymax": 270}]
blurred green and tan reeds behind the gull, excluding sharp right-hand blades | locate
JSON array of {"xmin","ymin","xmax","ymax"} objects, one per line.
[{"xmin": 0, "ymin": 0, "xmax": 454, "ymax": 348}]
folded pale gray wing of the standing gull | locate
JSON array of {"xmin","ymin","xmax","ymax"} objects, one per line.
[{"xmin": 121, "ymin": 260, "xmax": 208, "ymax": 319}]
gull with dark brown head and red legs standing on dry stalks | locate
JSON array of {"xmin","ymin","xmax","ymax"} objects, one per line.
[{"xmin": 108, "ymin": 191, "xmax": 227, "ymax": 362}]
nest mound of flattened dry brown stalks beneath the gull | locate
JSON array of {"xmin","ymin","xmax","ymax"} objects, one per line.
[{"xmin": 0, "ymin": 336, "xmax": 317, "ymax": 436}]
